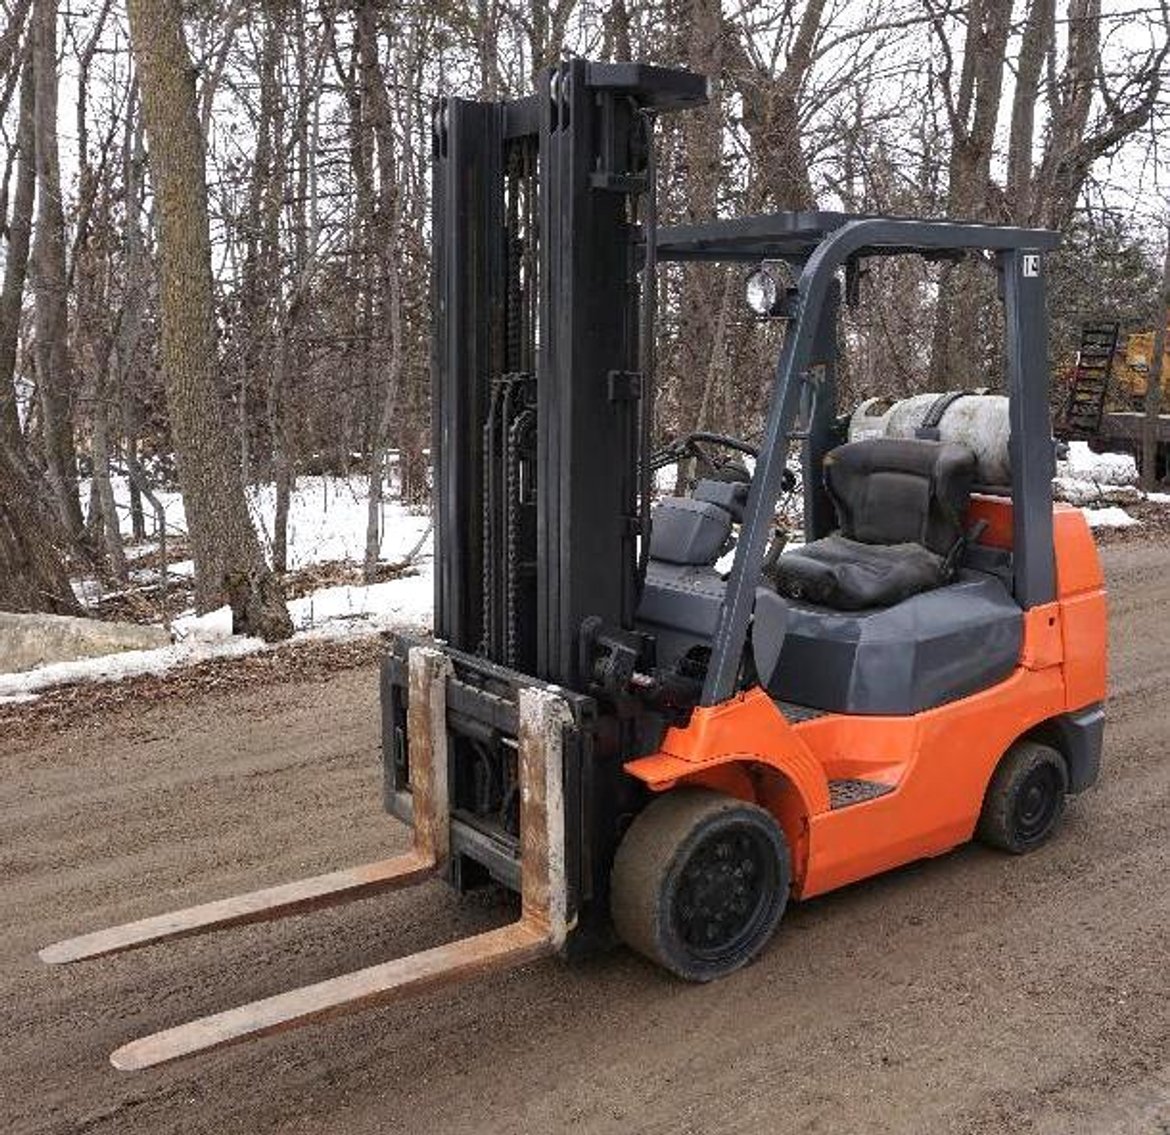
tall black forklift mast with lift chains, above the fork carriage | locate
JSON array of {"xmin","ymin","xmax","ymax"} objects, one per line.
[{"xmin": 432, "ymin": 60, "xmax": 707, "ymax": 689}]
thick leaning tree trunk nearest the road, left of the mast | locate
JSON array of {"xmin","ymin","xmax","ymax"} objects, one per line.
[{"xmin": 128, "ymin": 0, "xmax": 293, "ymax": 640}]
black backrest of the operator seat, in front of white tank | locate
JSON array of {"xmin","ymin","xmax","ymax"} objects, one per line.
[{"xmin": 825, "ymin": 438, "xmax": 976, "ymax": 556}]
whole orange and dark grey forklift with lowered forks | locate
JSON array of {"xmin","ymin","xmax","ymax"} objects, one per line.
[{"xmin": 42, "ymin": 60, "xmax": 1106, "ymax": 1068}]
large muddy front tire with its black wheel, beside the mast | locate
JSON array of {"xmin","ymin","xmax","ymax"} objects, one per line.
[{"xmin": 611, "ymin": 789, "xmax": 791, "ymax": 982}]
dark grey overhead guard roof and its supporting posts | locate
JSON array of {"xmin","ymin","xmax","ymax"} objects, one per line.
[{"xmin": 687, "ymin": 212, "xmax": 1060, "ymax": 706}]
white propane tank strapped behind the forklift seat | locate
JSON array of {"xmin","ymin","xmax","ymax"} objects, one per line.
[{"xmin": 849, "ymin": 394, "xmax": 1012, "ymax": 487}]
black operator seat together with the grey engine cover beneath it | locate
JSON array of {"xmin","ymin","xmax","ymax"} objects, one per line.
[{"xmin": 751, "ymin": 438, "xmax": 1024, "ymax": 715}]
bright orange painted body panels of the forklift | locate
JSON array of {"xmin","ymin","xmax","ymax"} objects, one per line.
[{"xmin": 625, "ymin": 505, "xmax": 1106, "ymax": 897}]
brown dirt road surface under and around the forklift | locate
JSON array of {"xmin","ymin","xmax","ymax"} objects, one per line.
[{"xmin": 0, "ymin": 541, "xmax": 1170, "ymax": 1135}]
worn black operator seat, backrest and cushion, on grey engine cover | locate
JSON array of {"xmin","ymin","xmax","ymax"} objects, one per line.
[{"xmin": 771, "ymin": 438, "xmax": 976, "ymax": 611}]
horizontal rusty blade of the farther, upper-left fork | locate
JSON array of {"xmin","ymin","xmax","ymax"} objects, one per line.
[{"xmin": 40, "ymin": 852, "xmax": 435, "ymax": 965}]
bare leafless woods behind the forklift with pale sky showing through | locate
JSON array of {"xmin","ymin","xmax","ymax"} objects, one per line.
[{"xmin": 0, "ymin": 0, "xmax": 1170, "ymax": 638}]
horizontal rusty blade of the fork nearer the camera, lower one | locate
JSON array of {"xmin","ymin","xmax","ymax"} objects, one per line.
[{"xmin": 110, "ymin": 920, "xmax": 553, "ymax": 1072}]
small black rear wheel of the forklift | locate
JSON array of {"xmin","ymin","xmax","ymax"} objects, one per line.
[{"xmin": 976, "ymin": 741, "xmax": 1068, "ymax": 855}]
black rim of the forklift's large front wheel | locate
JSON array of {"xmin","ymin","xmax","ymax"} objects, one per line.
[{"xmin": 670, "ymin": 824, "xmax": 777, "ymax": 959}]
